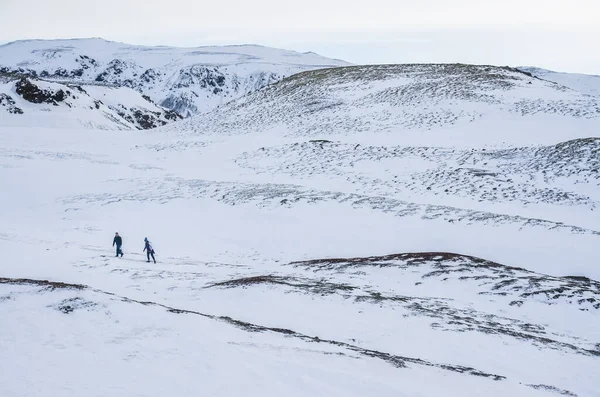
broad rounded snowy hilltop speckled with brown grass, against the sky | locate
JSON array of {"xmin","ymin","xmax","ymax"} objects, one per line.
[{"xmin": 167, "ymin": 64, "xmax": 600, "ymax": 139}]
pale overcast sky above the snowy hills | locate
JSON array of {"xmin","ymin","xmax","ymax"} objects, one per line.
[{"xmin": 0, "ymin": 0, "xmax": 600, "ymax": 74}]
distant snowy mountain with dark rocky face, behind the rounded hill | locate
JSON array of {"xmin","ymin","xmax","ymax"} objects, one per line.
[{"xmin": 0, "ymin": 39, "xmax": 347, "ymax": 116}]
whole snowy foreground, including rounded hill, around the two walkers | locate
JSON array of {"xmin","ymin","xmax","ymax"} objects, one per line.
[{"xmin": 0, "ymin": 63, "xmax": 600, "ymax": 397}]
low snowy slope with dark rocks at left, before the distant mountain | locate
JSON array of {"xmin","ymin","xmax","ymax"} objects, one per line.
[{"xmin": 0, "ymin": 76, "xmax": 181, "ymax": 130}]
